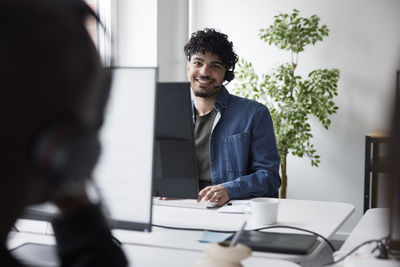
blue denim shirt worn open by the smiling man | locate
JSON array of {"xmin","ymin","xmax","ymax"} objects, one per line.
[{"xmin": 192, "ymin": 87, "xmax": 281, "ymax": 199}]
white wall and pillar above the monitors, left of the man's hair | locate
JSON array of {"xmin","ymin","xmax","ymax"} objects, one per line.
[{"xmin": 112, "ymin": 0, "xmax": 189, "ymax": 78}]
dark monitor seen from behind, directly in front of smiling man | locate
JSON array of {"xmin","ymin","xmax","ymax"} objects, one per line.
[{"xmin": 153, "ymin": 82, "xmax": 199, "ymax": 199}]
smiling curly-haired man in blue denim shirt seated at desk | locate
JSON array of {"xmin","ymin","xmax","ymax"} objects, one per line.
[{"xmin": 184, "ymin": 28, "xmax": 281, "ymax": 206}]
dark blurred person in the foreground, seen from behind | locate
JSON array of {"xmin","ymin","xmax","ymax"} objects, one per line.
[{"xmin": 0, "ymin": 0, "xmax": 127, "ymax": 266}]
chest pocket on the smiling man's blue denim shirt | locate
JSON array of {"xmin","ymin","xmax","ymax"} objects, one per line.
[{"xmin": 223, "ymin": 132, "xmax": 250, "ymax": 177}]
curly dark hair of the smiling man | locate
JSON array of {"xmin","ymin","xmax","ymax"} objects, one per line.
[{"xmin": 184, "ymin": 28, "xmax": 238, "ymax": 70}]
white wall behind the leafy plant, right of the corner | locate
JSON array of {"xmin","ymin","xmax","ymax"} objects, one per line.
[{"xmin": 192, "ymin": 0, "xmax": 400, "ymax": 238}]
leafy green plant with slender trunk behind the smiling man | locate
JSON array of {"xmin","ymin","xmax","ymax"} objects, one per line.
[{"xmin": 233, "ymin": 9, "xmax": 339, "ymax": 198}]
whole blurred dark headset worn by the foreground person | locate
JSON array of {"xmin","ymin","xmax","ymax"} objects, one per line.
[{"xmin": 30, "ymin": 0, "xmax": 112, "ymax": 197}]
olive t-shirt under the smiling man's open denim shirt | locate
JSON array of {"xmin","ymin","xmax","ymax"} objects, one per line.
[{"xmin": 194, "ymin": 109, "xmax": 217, "ymax": 190}]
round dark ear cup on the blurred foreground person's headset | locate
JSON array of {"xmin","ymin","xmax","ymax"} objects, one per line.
[{"xmin": 32, "ymin": 123, "xmax": 100, "ymax": 189}]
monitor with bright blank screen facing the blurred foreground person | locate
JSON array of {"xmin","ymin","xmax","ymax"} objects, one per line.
[{"xmin": 23, "ymin": 67, "xmax": 157, "ymax": 231}]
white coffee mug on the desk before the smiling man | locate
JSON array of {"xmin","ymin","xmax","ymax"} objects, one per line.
[{"xmin": 242, "ymin": 197, "xmax": 279, "ymax": 225}]
